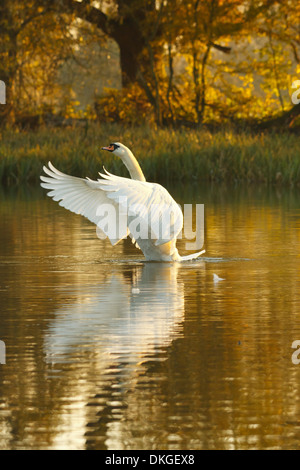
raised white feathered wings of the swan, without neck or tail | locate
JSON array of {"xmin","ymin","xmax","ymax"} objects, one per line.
[{"xmin": 41, "ymin": 162, "xmax": 183, "ymax": 245}]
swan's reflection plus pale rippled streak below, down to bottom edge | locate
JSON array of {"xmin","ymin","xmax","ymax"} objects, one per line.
[{"xmin": 44, "ymin": 263, "xmax": 200, "ymax": 449}]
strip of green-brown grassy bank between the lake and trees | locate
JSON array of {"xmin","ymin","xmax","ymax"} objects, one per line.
[{"xmin": 0, "ymin": 125, "xmax": 300, "ymax": 185}]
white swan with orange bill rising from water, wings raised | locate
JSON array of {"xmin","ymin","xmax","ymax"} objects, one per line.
[{"xmin": 41, "ymin": 142, "xmax": 205, "ymax": 261}]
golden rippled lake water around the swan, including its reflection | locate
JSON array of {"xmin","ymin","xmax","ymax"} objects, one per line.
[{"xmin": 0, "ymin": 187, "xmax": 300, "ymax": 449}]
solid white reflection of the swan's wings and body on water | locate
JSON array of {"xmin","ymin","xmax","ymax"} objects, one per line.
[{"xmin": 44, "ymin": 263, "xmax": 184, "ymax": 369}]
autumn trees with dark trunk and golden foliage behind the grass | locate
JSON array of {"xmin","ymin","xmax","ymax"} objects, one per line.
[{"xmin": 0, "ymin": 0, "xmax": 300, "ymax": 127}]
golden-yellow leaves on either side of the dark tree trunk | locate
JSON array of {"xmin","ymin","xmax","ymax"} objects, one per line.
[{"xmin": 0, "ymin": 0, "xmax": 300, "ymax": 123}]
